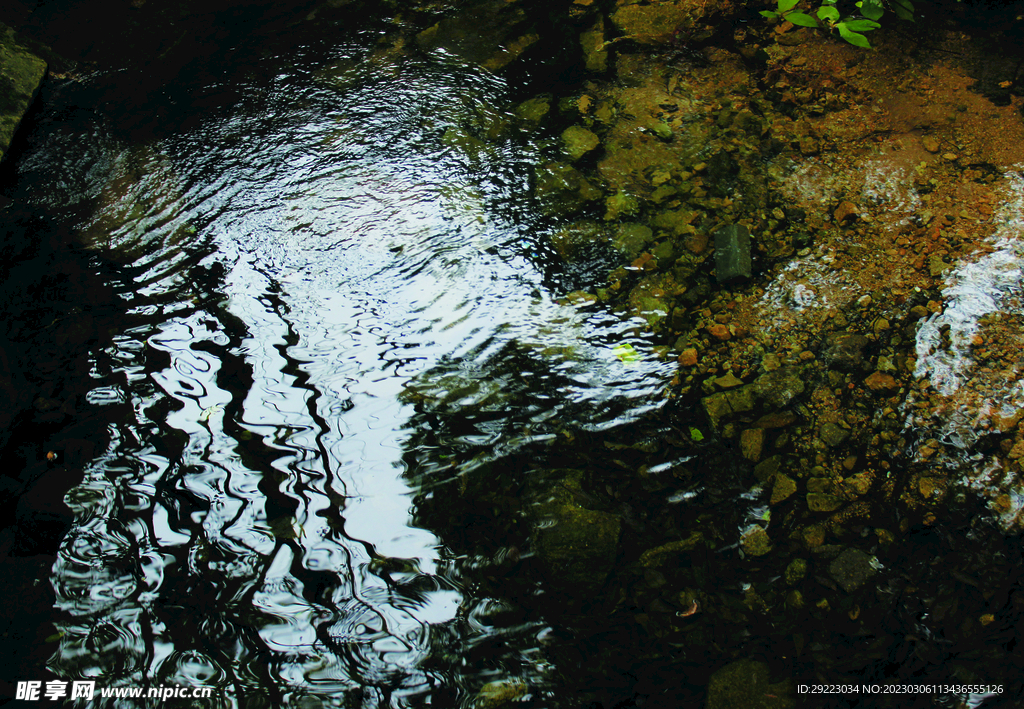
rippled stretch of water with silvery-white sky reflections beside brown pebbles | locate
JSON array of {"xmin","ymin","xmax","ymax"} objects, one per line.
[{"xmin": 12, "ymin": 20, "xmax": 672, "ymax": 707}]
